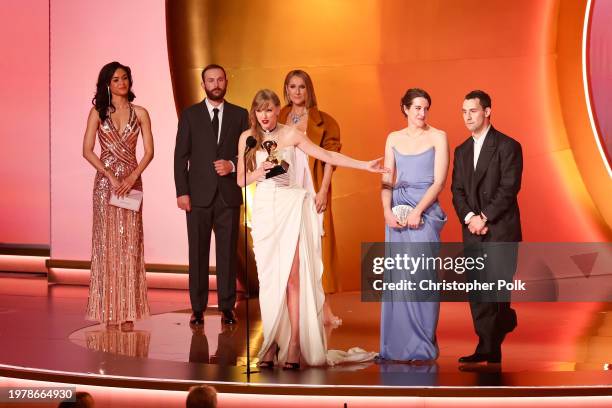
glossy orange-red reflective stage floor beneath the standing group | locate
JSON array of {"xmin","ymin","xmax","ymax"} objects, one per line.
[{"xmin": 0, "ymin": 274, "xmax": 612, "ymax": 397}]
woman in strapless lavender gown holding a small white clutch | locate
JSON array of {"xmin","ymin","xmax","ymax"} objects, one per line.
[{"xmin": 380, "ymin": 88, "xmax": 449, "ymax": 361}]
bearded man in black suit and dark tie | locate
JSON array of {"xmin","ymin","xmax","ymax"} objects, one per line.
[{"xmin": 174, "ymin": 64, "xmax": 249, "ymax": 325}]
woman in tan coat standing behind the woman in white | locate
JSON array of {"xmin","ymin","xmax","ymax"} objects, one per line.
[{"xmin": 278, "ymin": 69, "xmax": 342, "ymax": 326}]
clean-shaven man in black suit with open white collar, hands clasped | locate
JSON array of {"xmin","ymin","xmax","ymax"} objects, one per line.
[{"xmin": 451, "ymin": 91, "xmax": 523, "ymax": 363}]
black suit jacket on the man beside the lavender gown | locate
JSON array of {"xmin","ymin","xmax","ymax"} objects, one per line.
[{"xmin": 451, "ymin": 126, "xmax": 523, "ymax": 242}]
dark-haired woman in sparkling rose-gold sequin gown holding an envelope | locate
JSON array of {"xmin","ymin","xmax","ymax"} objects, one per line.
[{"xmin": 83, "ymin": 62, "xmax": 153, "ymax": 328}]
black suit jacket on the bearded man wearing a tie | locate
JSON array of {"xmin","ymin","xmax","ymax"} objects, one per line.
[{"xmin": 174, "ymin": 101, "xmax": 249, "ymax": 207}]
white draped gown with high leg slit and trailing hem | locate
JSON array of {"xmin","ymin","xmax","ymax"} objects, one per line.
[{"xmin": 251, "ymin": 146, "xmax": 374, "ymax": 366}]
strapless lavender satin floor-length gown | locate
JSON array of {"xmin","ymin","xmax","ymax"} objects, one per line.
[{"xmin": 380, "ymin": 147, "xmax": 446, "ymax": 361}]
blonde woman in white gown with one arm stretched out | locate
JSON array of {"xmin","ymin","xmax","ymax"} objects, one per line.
[{"xmin": 237, "ymin": 89, "xmax": 388, "ymax": 370}]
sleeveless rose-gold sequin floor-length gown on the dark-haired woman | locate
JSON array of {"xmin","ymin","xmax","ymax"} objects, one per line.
[{"xmin": 86, "ymin": 104, "xmax": 149, "ymax": 324}]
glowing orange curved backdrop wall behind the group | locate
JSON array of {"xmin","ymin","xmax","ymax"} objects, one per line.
[{"xmin": 167, "ymin": 0, "xmax": 612, "ymax": 290}]
